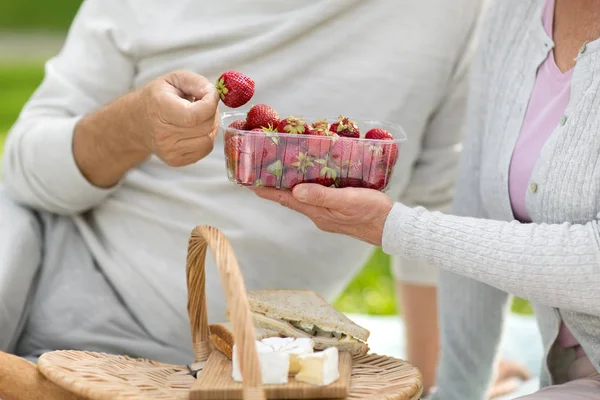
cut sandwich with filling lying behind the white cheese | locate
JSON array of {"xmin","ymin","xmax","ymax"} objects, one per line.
[{"xmin": 210, "ymin": 290, "xmax": 370, "ymax": 358}]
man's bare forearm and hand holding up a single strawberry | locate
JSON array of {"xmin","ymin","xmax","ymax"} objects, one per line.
[{"xmin": 73, "ymin": 71, "xmax": 219, "ymax": 188}]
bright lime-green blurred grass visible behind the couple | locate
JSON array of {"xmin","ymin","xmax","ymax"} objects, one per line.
[{"xmin": 0, "ymin": 63, "xmax": 532, "ymax": 315}]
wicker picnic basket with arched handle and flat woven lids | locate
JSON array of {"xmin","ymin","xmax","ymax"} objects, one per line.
[{"xmin": 0, "ymin": 226, "xmax": 422, "ymax": 400}]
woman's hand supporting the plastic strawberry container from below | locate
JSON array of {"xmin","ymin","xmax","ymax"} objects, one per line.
[{"xmin": 251, "ymin": 183, "xmax": 393, "ymax": 246}]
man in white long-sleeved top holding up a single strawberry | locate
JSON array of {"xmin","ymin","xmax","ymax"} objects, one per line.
[{"xmin": 0, "ymin": 0, "xmax": 506, "ymax": 396}]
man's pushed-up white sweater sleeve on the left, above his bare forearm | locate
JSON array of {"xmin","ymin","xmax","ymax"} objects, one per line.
[{"xmin": 2, "ymin": 0, "xmax": 135, "ymax": 215}]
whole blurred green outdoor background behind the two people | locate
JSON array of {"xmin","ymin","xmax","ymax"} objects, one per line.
[{"xmin": 0, "ymin": 0, "xmax": 531, "ymax": 315}]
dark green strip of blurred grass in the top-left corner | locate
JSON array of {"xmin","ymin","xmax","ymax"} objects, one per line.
[{"xmin": 0, "ymin": 0, "xmax": 81, "ymax": 31}]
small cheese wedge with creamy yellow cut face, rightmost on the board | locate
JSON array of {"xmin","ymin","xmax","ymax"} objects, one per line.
[{"xmin": 295, "ymin": 347, "xmax": 340, "ymax": 386}]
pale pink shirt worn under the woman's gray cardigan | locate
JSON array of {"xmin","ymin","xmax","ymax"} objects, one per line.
[{"xmin": 509, "ymin": 0, "xmax": 585, "ymax": 356}]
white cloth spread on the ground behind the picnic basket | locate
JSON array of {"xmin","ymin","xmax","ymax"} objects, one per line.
[{"xmin": 348, "ymin": 314, "xmax": 543, "ymax": 400}]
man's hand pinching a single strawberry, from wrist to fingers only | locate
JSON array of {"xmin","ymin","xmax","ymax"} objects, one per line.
[{"xmin": 132, "ymin": 71, "xmax": 219, "ymax": 167}]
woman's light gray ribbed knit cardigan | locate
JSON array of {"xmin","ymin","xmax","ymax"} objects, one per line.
[{"xmin": 383, "ymin": 0, "xmax": 600, "ymax": 400}]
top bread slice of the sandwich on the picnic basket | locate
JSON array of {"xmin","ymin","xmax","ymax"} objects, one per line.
[{"xmin": 248, "ymin": 290, "xmax": 370, "ymax": 342}]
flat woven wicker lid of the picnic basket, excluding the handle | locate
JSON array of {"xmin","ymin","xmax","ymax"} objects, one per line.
[{"xmin": 38, "ymin": 351, "xmax": 422, "ymax": 400}]
